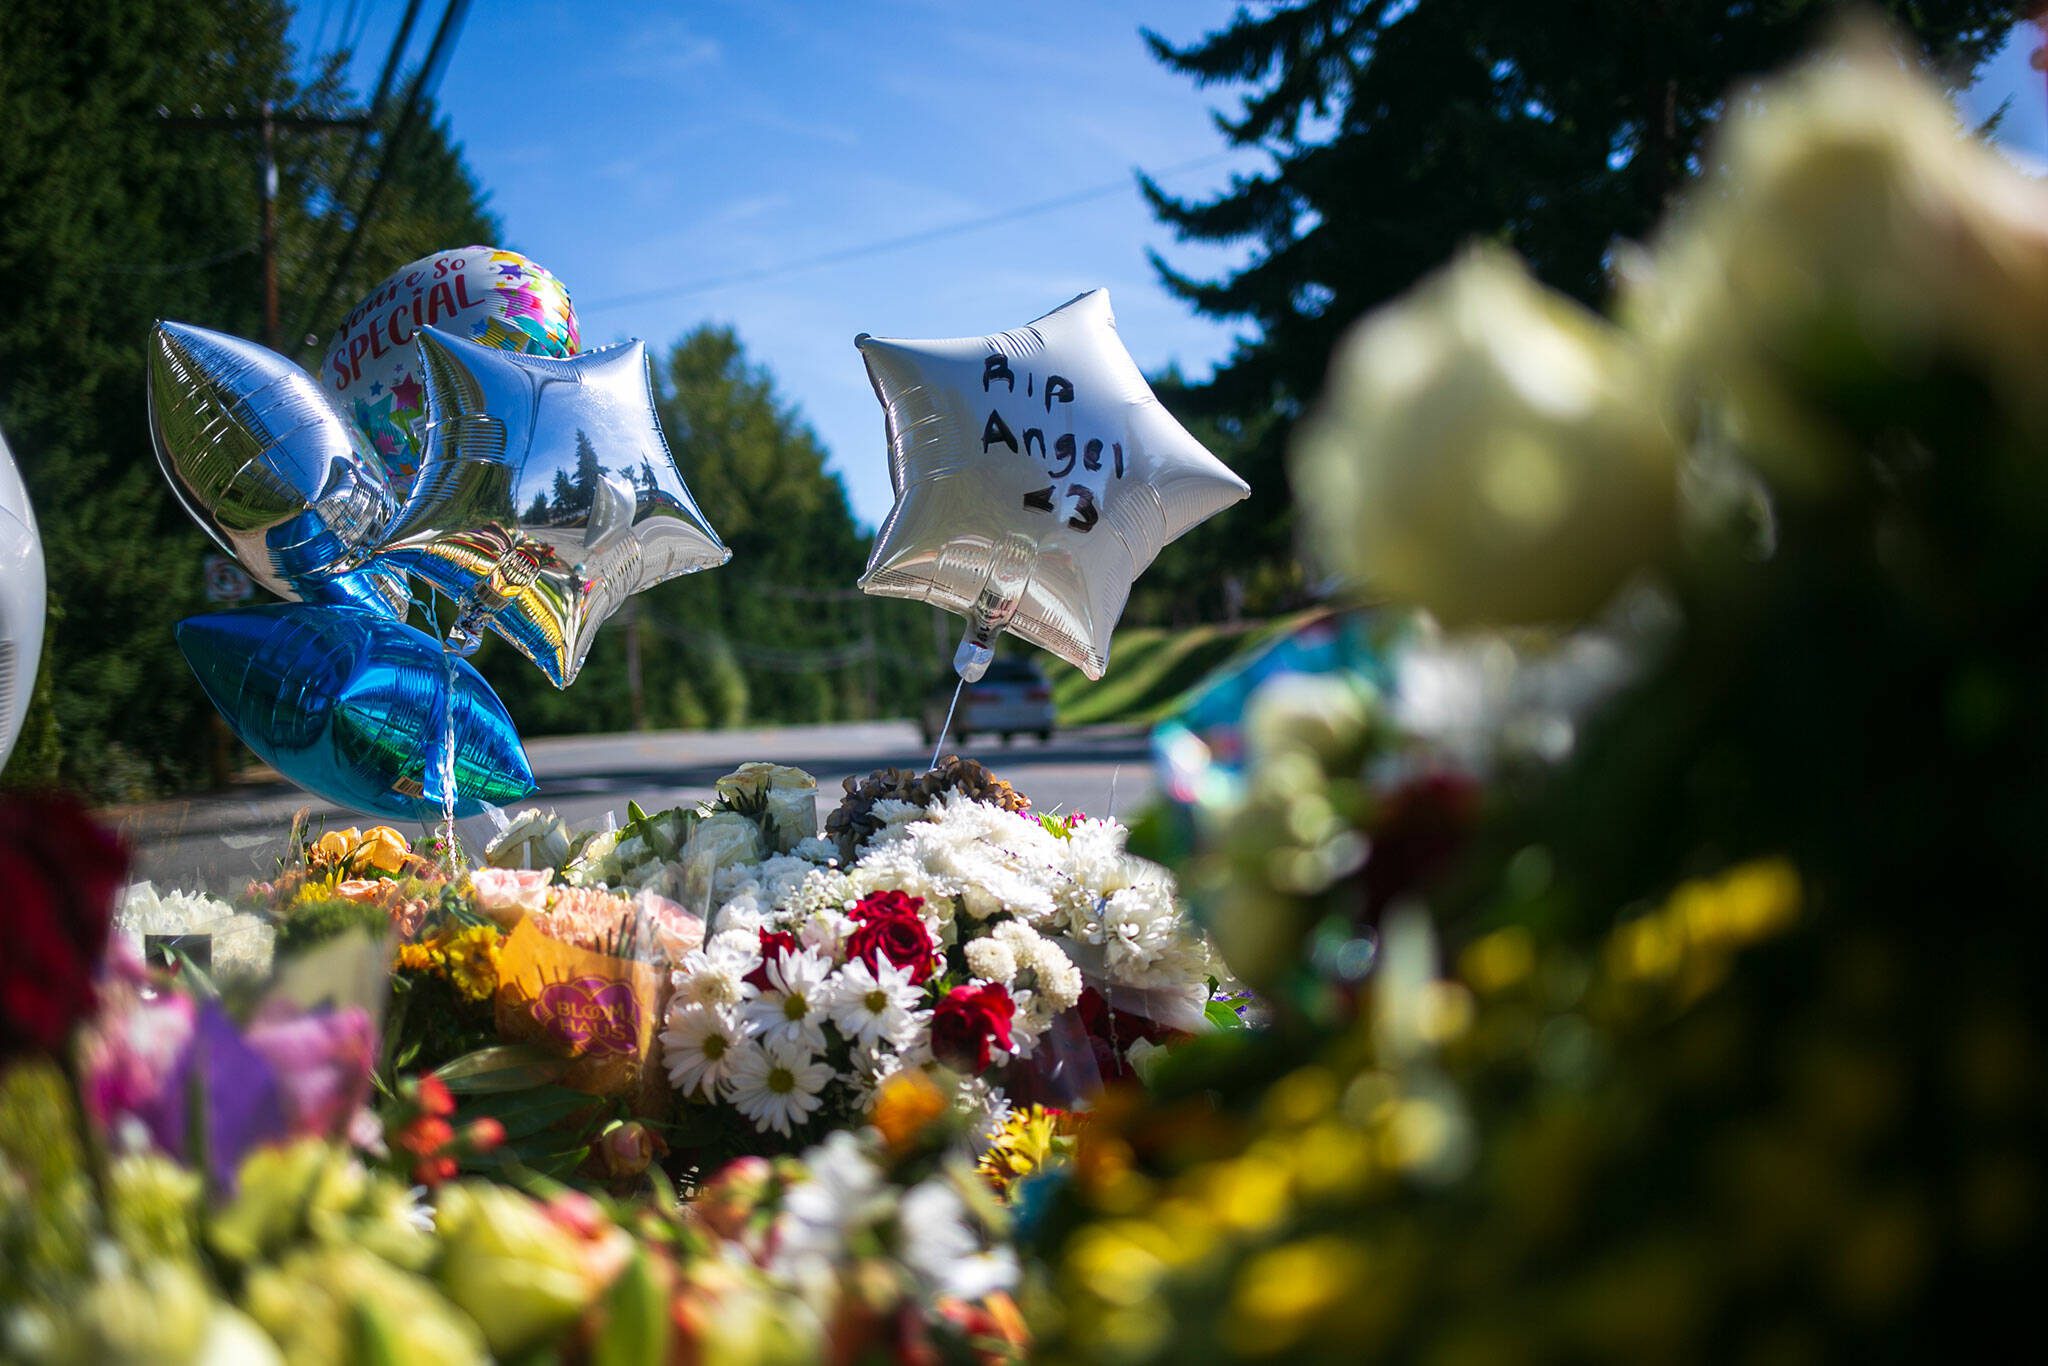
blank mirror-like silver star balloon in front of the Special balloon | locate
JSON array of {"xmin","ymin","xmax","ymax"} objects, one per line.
[{"xmin": 377, "ymin": 328, "xmax": 733, "ymax": 688}]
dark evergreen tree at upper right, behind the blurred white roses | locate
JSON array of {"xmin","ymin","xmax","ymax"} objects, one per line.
[{"xmin": 1143, "ymin": 0, "xmax": 2019, "ymax": 598}]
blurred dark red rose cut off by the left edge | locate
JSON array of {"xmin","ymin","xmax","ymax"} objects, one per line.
[{"xmin": 0, "ymin": 797, "xmax": 129, "ymax": 1061}]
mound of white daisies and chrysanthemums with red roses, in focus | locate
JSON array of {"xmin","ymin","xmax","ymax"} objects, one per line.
[{"xmin": 662, "ymin": 791, "xmax": 1221, "ymax": 1141}]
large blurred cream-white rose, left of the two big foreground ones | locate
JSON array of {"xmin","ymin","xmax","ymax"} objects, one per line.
[{"xmin": 1292, "ymin": 248, "xmax": 1677, "ymax": 625}]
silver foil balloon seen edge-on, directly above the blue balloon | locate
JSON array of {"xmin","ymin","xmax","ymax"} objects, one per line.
[{"xmin": 150, "ymin": 322, "xmax": 406, "ymax": 616}]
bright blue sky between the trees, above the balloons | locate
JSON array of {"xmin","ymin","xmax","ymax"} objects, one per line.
[{"xmin": 293, "ymin": 0, "xmax": 2048, "ymax": 524}]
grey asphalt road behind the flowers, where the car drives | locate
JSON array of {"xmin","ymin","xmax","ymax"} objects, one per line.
[{"xmin": 104, "ymin": 721, "xmax": 1153, "ymax": 895}]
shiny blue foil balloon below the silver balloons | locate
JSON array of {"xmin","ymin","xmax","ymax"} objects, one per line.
[{"xmin": 178, "ymin": 602, "xmax": 532, "ymax": 821}]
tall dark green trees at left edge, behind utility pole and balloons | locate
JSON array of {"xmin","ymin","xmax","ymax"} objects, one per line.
[{"xmin": 0, "ymin": 0, "xmax": 498, "ymax": 799}]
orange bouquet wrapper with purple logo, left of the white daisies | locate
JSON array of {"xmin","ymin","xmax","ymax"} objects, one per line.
[{"xmin": 496, "ymin": 920, "xmax": 670, "ymax": 1118}]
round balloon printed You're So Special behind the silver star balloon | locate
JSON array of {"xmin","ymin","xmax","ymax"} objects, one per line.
[{"xmin": 319, "ymin": 246, "xmax": 584, "ymax": 502}]
